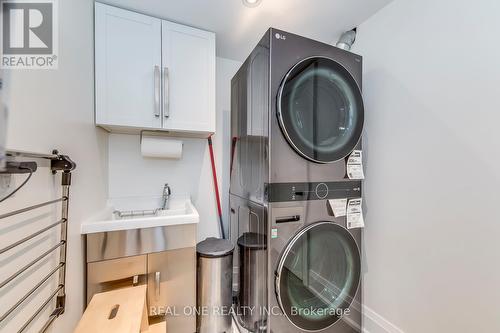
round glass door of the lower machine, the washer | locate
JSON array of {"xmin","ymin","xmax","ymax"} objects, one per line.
[{"xmin": 276, "ymin": 222, "xmax": 361, "ymax": 331}]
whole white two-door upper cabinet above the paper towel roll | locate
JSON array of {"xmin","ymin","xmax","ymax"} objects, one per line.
[{"xmin": 95, "ymin": 3, "xmax": 215, "ymax": 137}]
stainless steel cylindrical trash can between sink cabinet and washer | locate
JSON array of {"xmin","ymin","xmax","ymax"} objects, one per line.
[{"xmin": 196, "ymin": 238, "xmax": 234, "ymax": 333}]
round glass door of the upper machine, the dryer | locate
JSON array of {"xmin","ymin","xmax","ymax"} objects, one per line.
[{"xmin": 278, "ymin": 57, "xmax": 364, "ymax": 163}]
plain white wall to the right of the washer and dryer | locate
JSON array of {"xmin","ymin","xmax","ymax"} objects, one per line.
[{"xmin": 354, "ymin": 0, "xmax": 500, "ymax": 333}]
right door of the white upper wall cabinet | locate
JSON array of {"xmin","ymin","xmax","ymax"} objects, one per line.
[{"xmin": 162, "ymin": 21, "xmax": 215, "ymax": 133}]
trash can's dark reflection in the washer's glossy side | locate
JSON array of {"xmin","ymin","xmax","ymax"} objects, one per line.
[{"xmin": 238, "ymin": 232, "xmax": 267, "ymax": 332}]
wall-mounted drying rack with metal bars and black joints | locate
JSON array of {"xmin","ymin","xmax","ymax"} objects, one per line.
[{"xmin": 0, "ymin": 150, "xmax": 76, "ymax": 333}]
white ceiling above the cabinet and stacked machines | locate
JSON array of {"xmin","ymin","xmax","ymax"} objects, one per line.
[{"xmin": 99, "ymin": 0, "xmax": 392, "ymax": 61}]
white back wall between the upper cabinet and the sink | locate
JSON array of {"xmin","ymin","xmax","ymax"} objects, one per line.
[{"xmin": 109, "ymin": 58, "xmax": 241, "ymax": 240}]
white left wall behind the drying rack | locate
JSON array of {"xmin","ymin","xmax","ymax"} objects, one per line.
[{"xmin": 0, "ymin": 0, "xmax": 108, "ymax": 333}]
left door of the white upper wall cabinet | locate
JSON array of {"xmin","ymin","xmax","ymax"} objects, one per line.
[{"xmin": 95, "ymin": 3, "xmax": 161, "ymax": 128}]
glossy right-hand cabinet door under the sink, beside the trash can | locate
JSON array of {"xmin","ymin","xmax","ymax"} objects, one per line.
[{"xmin": 147, "ymin": 247, "xmax": 196, "ymax": 333}]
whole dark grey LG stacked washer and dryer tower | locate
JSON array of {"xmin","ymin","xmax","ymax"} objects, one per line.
[{"xmin": 230, "ymin": 29, "xmax": 364, "ymax": 333}]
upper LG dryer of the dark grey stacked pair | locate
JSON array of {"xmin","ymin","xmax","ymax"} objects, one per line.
[{"xmin": 231, "ymin": 29, "xmax": 364, "ymax": 202}]
